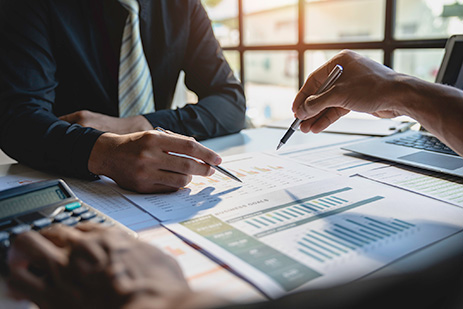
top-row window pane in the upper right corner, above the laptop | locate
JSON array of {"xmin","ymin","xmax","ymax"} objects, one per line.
[{"xmin": 395, "ymin": 0, "xmax": 463, "ymax": 39}]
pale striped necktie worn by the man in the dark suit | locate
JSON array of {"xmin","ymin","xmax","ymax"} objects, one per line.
[{"xmin": 119, "ymin": 0, "xmax": 154, "ymax": 117}]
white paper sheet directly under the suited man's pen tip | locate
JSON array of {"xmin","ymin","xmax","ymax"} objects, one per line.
[{"xmin": 114, "ymin": 153, "xmax": 335, "ymax": 221}]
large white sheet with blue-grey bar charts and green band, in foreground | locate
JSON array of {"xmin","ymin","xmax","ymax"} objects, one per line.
[{"xmin": 167, "ymin": 177, "xmax": 463, "ymax": 297}]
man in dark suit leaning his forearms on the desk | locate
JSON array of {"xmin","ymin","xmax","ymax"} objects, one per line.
[{"xmin": 0, "ymin": 0, "xmax": 245, "ymax": 192}]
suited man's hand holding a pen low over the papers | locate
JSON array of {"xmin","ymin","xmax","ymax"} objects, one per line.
[{"xmin": 88, "ymin": 130, "xmax": 222, "ymax": 193}]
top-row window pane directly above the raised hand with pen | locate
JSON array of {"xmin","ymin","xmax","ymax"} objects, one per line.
[{"xmin": 304, "ymin": 0, "xmax": 386, "ymax": 43}]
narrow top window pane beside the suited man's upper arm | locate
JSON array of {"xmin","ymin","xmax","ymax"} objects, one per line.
[{"xmin": 202, "ymin": 0, "xmax": 240, "ymax": 47}]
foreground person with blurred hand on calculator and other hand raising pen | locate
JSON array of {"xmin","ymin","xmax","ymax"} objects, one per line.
[{"xmin": 3, "ymin": 51, "xmax": 463, "ymax": 309}]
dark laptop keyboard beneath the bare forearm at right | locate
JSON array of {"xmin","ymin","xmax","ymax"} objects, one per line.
[{"xmin": 386, "ymin": 133, "xmax": 458, "ymax": 156}]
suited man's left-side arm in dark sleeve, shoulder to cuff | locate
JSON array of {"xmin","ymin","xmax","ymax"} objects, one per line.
[{"xmin": 0, "ymin": 0, "xmax": 102, "ymax": 176}]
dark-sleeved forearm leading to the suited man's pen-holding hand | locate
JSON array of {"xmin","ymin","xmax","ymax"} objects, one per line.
[{"xmin": 0, "ymin": 105, "xmax": 102, "ymax": 177}]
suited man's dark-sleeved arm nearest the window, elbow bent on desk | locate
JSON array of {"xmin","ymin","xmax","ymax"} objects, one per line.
[{"xmin": 145, "ymin": 0, "xmax": 246, "ymax": 139}]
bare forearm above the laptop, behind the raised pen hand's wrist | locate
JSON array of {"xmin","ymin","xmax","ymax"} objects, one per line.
[{"xmin": 397, "ymin": 75, "xmax": 463, "ymax": 155}]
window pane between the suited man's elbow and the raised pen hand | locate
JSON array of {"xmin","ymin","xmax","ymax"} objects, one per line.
[{"xmin": 244, "ymin": 51, "xmax": 298, "ymax": 126}]
